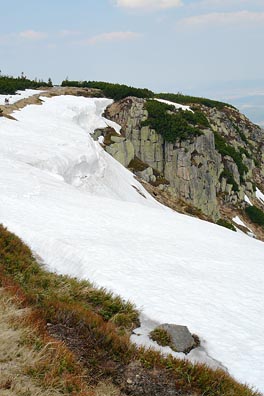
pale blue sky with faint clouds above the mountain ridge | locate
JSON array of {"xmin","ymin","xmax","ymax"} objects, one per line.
[{"xmin": 0, "ymin": 0, "xmax": 264, "ymax": 97}]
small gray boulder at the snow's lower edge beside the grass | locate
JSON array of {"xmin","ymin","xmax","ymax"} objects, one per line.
[{"xmin": 158, "ymin": 323, "xmax": 195, "ymax": 353}]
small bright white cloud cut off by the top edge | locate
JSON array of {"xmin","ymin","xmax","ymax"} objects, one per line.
[{"xmin": 114, "ymin": 0, "xmax": 182, "ymax": 10}]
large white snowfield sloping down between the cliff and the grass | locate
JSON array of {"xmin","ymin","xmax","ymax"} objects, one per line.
[{"xmin": 0, "ymin": 96, "xmax": 264, "ymax": 390}]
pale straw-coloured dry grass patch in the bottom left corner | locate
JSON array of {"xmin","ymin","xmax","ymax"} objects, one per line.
[{"xmin": 0, "ymin": 288, "xmax": 120, "ymax": 396}]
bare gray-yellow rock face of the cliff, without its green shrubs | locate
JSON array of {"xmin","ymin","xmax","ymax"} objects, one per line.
[{"xmin": 100, "ymin": 97, "xmax": 264, "ymax": 221}]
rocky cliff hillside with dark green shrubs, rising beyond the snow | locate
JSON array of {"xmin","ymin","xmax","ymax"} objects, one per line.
[{"xmin": 96, "ymin": 91, "xmax": 264, "ymax": 240}]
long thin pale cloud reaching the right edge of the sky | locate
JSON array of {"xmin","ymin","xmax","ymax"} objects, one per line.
[{"xmin": 177, "ymin": 11, "xmax": 264, "ymax": 28}]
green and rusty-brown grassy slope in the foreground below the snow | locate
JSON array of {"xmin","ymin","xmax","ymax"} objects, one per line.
[{"xmin": 0, "ymin": 226, "xmax": 259, "ymax": 396}]
